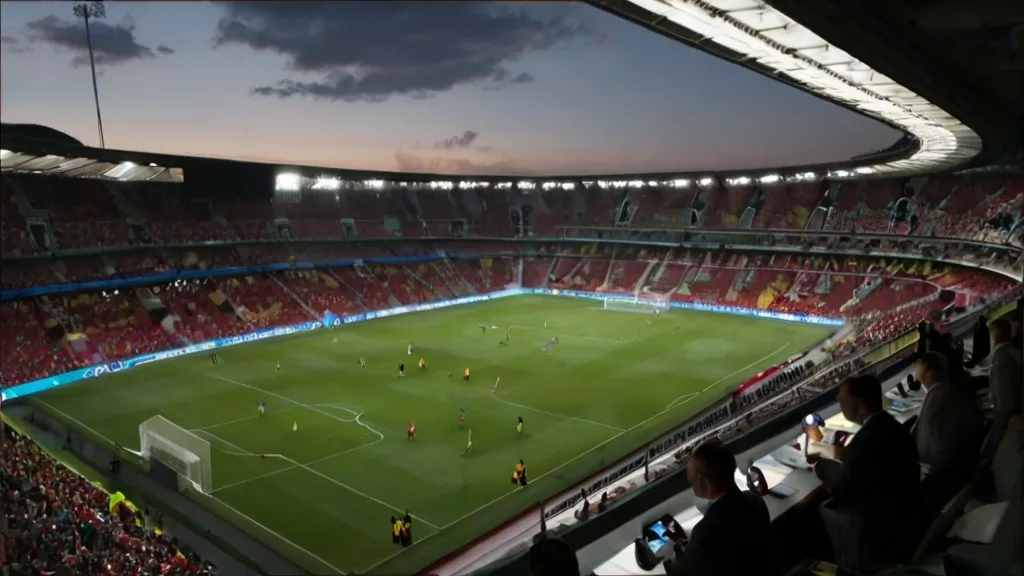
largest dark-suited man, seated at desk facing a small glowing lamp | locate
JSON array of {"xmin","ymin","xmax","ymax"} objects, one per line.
[{"xmin": 821, "ymin": 375, "xmax": 922, "ymax": 573}]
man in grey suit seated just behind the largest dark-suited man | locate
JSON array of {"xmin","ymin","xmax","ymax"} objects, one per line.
[{"xmin": 913, "ymin": 352, "xmax": 982, "ymax": 513}]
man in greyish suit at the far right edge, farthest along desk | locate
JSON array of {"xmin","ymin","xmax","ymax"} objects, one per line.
[{"xmin": 982, "ymin": 318, "xmax": 1024, "ymax": 456}]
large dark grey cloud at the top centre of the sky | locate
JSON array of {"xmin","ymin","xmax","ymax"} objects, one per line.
[{"xmin": 214, "ymin": 2, "xmax": 590, "ymax": 102}]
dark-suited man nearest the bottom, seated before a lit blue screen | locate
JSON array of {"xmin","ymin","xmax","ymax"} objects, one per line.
[{"xmin": 665, "ymin": 442, "xmax": 778, "ymax": 576}]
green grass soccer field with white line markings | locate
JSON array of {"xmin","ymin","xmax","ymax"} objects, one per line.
[{"xmin": 29, "ymin": 296, "xmax": 830, "ymax": 574}]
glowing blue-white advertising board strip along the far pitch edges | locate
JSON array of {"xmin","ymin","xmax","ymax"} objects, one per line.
[{"xmin": 0, "ymin": 288, "xmax": 843, "ymax": 402}]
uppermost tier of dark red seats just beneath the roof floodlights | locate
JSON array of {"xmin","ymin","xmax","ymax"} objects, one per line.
[{"xmin": 0, "ymin": 170, "xmax": 1024, "ymax": 254}]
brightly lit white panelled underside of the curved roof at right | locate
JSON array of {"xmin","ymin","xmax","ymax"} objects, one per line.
[{"xmin": 591, "ymin": 0, "xmax": 982, "ymax": 176}]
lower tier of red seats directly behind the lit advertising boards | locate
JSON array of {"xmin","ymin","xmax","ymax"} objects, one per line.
[{"xmin": 0, "ymin": 245, "xmax": 1014, "ymax": 385}]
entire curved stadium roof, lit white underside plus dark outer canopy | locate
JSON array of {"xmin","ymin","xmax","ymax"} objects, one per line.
[{"xmin": 0, "ymin": 0, "xmax": 1024, "ymax": 181}]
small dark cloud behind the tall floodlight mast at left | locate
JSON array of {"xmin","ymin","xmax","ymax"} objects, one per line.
[{"xmin": 26, "ymin": 15, "xmax": 174, "ymax": 67}]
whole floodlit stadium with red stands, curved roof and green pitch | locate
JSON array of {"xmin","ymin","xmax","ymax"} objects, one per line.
[{"xmin": 0, "ymin": 0, "xmax": 1024, "ymax": 574}]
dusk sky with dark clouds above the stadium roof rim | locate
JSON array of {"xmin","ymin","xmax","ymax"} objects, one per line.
[{"xmin": 0, "ymin": 1, "xmax": 899, "ymax": 176}]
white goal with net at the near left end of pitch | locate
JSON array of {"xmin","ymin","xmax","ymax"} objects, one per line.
[{"xmin": 138, "ymin": 415, "xmax": 213, "ymax": 494}]
